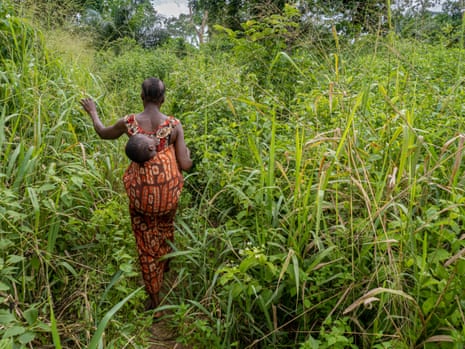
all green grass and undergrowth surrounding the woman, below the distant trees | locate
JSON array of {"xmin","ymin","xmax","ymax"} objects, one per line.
[{"xmin": 0, "ymin": 1, "xmax": 465, "ymax": 349}]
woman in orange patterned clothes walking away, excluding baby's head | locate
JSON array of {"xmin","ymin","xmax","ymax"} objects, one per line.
[{"xmin": 81, "ymin": 78, "xmax": 192, "ymax": 317}]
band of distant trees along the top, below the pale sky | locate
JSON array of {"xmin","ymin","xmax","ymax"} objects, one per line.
[{"xmin": 10, "ymin": 0, "xmax": 463, "ymax": 48}]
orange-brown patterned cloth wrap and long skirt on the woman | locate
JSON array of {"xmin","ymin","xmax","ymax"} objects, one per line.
[{"xmin": 123, "ymin": 145, "xmax": 184, "ymax": 296}]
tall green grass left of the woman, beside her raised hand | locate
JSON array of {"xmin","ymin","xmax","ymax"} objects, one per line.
[{"xmin": 0, "ymin": 5, "xmax": 150, "ymax": 348}]
